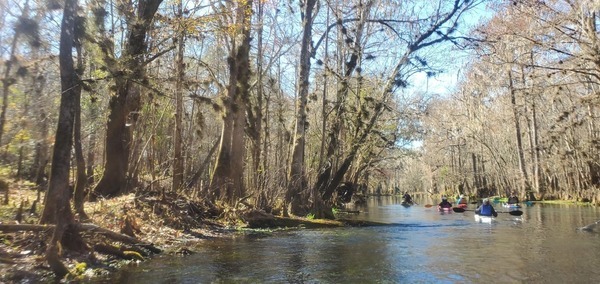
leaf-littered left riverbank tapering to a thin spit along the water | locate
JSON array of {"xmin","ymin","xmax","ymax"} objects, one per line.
[{"xmin": 0, "ymin": 180, "xmax": 370, "ymax": 283}]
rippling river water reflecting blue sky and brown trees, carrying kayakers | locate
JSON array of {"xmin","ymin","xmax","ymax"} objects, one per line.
[{"xmin": 99, "ymin": 197, "xmax": 600, "ymax": 284}]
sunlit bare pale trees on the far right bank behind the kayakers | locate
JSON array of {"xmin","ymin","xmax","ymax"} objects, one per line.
[{"xmin": 420, "ymin": 1, "xmax": 600, "ymax": 204}]
